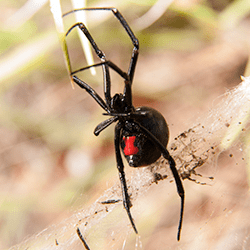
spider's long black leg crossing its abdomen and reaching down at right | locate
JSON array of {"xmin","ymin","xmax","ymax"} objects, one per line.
[{"xmin": 135, "ymin": 122, "xmax": 185, "ymax": 241}]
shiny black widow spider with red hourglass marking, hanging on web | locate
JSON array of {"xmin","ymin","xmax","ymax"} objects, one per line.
[{"xmin": 63, "ymin": 8, "xmax": 184, "ymax": 240}]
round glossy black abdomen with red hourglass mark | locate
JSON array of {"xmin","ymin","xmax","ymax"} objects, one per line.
[{"xmin": 121, "ymin": 107, "xmax": 169, "ymax": 167}]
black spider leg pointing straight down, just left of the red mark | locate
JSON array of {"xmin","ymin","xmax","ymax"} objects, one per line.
[{"xmin": 115, "ymin": 122, "xmax": 138, "ymax": 234}]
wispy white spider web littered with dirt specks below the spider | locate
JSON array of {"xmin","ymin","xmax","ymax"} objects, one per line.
[{"xmin": 8, "ymin": 77, "xmax": 250, "ymax": 250}]
